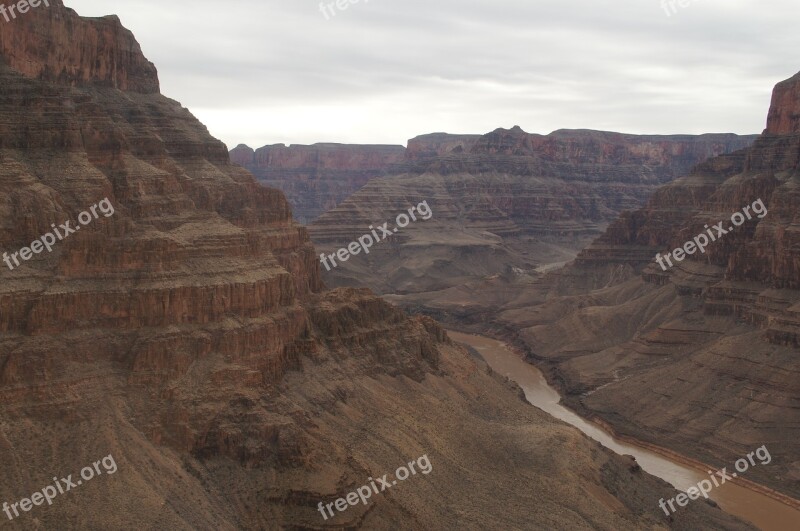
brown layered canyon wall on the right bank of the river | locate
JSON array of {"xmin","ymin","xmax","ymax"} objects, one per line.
[{"xmin": 406, "ymin": 72, "xmax": 800, "ymax": 498}]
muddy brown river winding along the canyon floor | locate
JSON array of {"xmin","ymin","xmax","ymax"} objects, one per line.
[{"xmin": 448, "ymin": 330, "xmax": 800, "ymax": 531}]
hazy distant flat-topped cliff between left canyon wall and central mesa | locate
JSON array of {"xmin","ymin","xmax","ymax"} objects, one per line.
[{"xmin": 231, "ymin": 144, "xmax": 405, "ymax": 224}]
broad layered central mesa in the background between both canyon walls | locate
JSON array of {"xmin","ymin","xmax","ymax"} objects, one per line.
[{"xmin": 309, "ymin": 127, "xmax": 755, "ymax": 294}]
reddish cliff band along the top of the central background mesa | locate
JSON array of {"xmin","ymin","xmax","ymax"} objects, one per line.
[{"xmin": 409, "ymin": 126, "xmax": 756, "ymax": 184}]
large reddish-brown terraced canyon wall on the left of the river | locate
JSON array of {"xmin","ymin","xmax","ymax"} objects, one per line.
[{"xmin": 0, "ymin": 2, "xmax": 760, "ymax": 530}]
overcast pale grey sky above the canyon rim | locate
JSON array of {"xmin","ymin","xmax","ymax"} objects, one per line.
[{"xmin": 65, "ymin": 0, "xmax": 800, "ymax": 147}]
